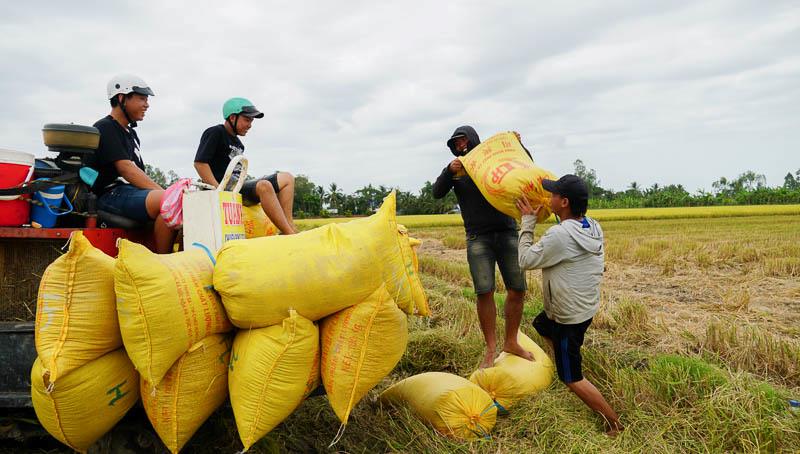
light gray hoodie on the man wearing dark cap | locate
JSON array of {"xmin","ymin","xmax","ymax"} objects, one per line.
[{"xmin": 519, "ymin": 216, "xmax": 605, "ymax": 324}]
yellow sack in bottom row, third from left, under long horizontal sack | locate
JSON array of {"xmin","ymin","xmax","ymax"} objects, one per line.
[{"xmin": 228, "ymin": 311, "xmax": 319, "ymax": 451}]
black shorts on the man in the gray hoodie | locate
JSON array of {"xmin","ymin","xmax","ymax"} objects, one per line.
[{"xmin": 533, "ymin": 311, "xmax": 592, "ymax": 383}]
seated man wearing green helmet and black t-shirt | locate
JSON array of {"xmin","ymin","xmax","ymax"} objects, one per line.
[{"xmin": 194, "ymin": 98, "xmax": 297, "ymax": 235}]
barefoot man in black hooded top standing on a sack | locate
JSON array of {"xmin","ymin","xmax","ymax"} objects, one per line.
[{"xmin": 433, "ymin": 126, "xmax": 533, "ymax": 368}]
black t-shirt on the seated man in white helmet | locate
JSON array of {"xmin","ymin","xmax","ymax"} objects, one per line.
[{"xmin": 92, "ymin": 115, "xmax": 144, "ymax": 195}]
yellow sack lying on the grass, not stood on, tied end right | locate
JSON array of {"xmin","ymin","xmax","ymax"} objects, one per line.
[{"xmin": 380, "ymin": 372, "xmax": 497, "ymax": 440}]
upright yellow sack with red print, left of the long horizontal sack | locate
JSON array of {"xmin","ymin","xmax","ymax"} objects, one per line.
[{"xmin": 114, "ymin": 240, "xmax": 232, "ymax": 386}]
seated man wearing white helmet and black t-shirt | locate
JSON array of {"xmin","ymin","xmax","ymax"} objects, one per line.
[{"xmin": 92, "ymin": 74, "xmax": 175, "ymax": 254}]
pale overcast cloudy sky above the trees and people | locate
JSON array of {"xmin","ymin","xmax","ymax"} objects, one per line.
[{"xmin": 0, "ymin": 0, "xmax": 800, "ymax": 192}]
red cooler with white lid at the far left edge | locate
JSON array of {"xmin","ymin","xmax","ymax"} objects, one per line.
[{"xmin": 0, "ymin": 149, "xmax": 35, "ymax": 227}]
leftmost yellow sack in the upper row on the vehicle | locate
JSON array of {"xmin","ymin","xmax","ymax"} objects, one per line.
[{"xmin": 35, "ymin": 231, "xmax": 122, "ymax": 386}]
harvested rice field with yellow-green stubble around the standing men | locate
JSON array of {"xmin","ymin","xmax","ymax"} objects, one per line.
[{"xmin": 256, "ymin": 206, "xmax": 800, "ymax": 453}]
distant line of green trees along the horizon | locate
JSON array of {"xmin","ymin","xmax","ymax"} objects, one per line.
[{"xmin": 146, "ymin": 159, "xmax": 800, "ymax": 218}]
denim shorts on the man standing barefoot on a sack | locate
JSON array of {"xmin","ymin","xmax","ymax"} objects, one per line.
[{"xmin": 467, "ymin": 230, "xmax": 527, "ymax": 295}]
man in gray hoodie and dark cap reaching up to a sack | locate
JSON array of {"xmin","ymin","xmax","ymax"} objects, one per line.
[{"xmin": 517, "ymin": 175, "xmax": 623, "ymax": 436}]
